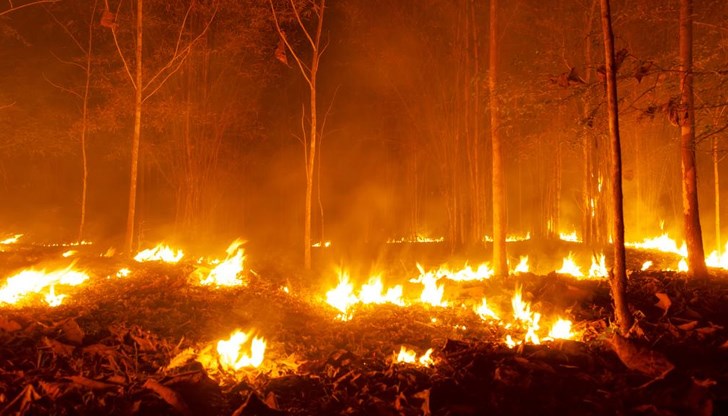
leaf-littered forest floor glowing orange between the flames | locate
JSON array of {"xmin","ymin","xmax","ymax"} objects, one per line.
[{"xmin": 0, "ymin": 245, "xmax": 728, "ymax": 415}]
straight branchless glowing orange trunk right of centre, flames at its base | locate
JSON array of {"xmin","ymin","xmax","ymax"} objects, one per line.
[{"xmin": 488, "ymin": 0, "xmax": 508, "ymax": 276}]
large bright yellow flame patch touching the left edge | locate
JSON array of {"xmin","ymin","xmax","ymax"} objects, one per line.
[{"xmin": 0, "ymin": 264, "xmax": 89, "ymax": 306}]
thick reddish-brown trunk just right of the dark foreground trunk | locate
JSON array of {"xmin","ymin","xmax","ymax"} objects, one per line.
[{"xmin": 680, "ymin": 0, "xmax": 708, "ymax": 277}]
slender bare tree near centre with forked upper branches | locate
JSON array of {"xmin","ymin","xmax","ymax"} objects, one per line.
[{"xmin": 268, "ymin": 0, "xmax": 326, "ymax": 270}]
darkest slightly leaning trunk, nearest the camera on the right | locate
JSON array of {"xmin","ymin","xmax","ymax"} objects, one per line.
[{"xmin": 601, "ymin": 0, "xmax": 632, "ymax": 335}]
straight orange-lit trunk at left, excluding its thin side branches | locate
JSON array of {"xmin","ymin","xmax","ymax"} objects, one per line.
[{"xmin": 124, "ymin": 0, "xmax": 143, "ymax": 255}]
